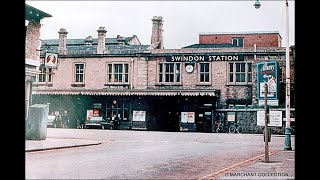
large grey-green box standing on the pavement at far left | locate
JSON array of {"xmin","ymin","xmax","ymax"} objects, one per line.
[{"xmin": 26, "ymin": 104, "xmax": 49, "ymax": 140}]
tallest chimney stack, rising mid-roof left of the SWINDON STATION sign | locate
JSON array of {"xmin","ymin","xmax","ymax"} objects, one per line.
[{"xmin": 151, "ymin": 16, "xmax": 163, "ymax": 49}]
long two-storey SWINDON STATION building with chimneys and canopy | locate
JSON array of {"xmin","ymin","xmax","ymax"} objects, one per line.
[{"xmin": 33, "ymin": 16, "xmax": 294, "ymax": 132}]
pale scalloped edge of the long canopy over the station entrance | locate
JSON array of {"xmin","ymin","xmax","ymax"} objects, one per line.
[{"xmin": 32, "ymin": 89, "xmax": 220, "ymax": 97}]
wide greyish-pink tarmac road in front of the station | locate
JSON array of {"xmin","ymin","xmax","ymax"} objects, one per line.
[{"xmin": 26, "ymin": 128, "xmax": 294, "ymax": 179}]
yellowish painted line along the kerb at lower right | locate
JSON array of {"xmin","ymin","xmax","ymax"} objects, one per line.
[{"xmin": 198, "ymin": 150, "xmax": 280, "ymax": 180}]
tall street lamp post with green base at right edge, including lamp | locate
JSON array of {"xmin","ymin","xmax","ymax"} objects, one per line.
[{"xmin": 254, "ymin": 0, "xmax": 292, "ymax": 150}]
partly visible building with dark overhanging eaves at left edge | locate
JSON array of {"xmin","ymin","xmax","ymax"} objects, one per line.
[{"xmin": 25, "ymin": 4, "xmax": 52, "ymax": 118}]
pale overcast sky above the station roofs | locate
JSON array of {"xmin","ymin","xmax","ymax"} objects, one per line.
[{"xmin": 26, "ymin": 0, "xmax": 295, "ymax": 49}]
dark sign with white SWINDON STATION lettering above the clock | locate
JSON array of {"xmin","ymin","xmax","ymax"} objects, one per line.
[{"xmin": 166, "ymin": 54, "xmax": 244, "ymax": 62}]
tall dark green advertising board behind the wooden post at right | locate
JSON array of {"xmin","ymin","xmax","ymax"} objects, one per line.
[{"xmin": 257, "ymin": 61, "xmax": 280, "ymax": 106}]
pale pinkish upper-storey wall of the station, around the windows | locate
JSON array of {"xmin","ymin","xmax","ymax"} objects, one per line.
[{"xmin": 35, "ymin": 45, "xmax": 294, "ymax": 107}]
